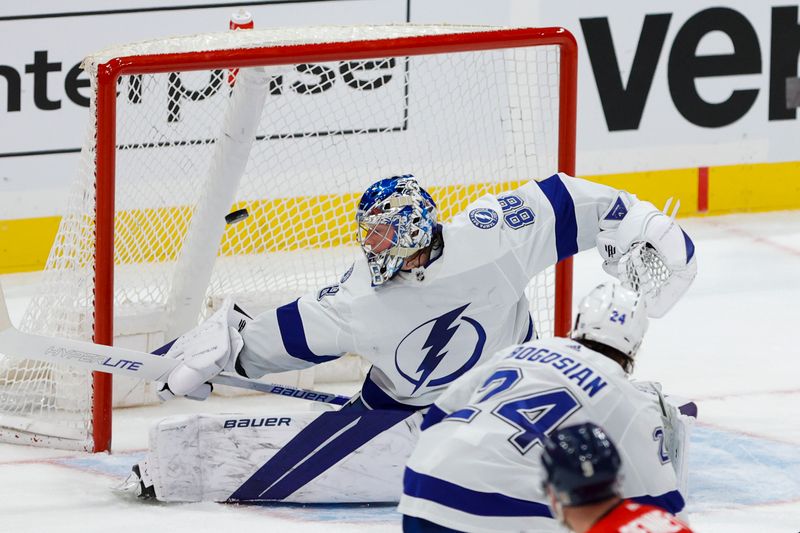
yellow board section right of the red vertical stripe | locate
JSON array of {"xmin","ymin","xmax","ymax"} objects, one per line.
[{"xmin": 708, "ymin": 161, "xmax": 800, "ymax": 214}]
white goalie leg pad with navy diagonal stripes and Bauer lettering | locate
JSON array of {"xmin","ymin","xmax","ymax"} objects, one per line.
[{"xmin": 141, "ymin": 411, "xmax": 421, "ymax": 503}]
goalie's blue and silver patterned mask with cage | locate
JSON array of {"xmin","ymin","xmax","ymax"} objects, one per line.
[{"xmin": 356, "ymin": 174, "xmax": 436, "ymax": 287}]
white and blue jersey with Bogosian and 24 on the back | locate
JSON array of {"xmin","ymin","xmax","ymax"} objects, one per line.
[{"xmin": 399, "ymin": 338, "xmax": 684, "ymax": 532}]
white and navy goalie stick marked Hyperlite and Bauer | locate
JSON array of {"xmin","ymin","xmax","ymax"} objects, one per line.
[{"xmin": 0, "ymin": 286, "xmax": 349, "ymax": 405}]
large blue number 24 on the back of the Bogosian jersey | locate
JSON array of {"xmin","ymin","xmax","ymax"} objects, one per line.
[{"xmin": 445, "ymin": 368, "xmax": 581, "ymax": 454}]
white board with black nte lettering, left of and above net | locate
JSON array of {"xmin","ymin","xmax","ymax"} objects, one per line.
[{"xmin": 0, "ymin": 0, "xmax": 408, "ymax": 216}]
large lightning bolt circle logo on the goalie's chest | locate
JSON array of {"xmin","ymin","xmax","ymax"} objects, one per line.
[{"xmin": 394, "ymin": 304, "xmax": 486, "ymax": 394}]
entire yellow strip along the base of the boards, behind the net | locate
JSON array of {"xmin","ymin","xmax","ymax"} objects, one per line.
[{"xmin": 0, "ymin": 162, "xmax": 800, "ymax": 274}]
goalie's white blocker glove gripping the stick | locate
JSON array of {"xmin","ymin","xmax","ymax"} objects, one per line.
[{"xmin": 159, "ymin": 299, "xmax": 244, "ymax": 400}]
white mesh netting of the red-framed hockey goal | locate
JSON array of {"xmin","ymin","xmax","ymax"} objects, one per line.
[{"xmin": 0, "ymin": 26, "xmax": 559, "ymax": 448}]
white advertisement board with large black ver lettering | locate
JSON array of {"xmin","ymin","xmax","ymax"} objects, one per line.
[{"xmin": 527, "ymin": 0, "xmax": 800, "ymax": 174}]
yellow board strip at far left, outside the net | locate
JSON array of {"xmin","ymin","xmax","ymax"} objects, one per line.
[{"xmin": 0, "ymin": 217, "xmax": 61, "ymax": 274}]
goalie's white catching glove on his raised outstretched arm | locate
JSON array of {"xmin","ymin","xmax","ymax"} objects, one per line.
[{"xmin": 597, "ymin": 199, "xmax": 697, "ymax": 318}]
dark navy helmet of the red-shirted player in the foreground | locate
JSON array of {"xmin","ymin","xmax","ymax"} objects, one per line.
[{"xmin": 542, "ymin": 422, "xmax": 622, "ymax": 506}]
